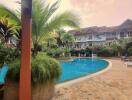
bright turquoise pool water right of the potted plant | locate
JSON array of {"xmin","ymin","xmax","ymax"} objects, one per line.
[{"xmin": 60, "ymin": 58, "xmax": 108, "ymax": 82}]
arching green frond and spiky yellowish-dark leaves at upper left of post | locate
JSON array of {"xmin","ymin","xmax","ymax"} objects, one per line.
[{"xmin": 0, "ymin": 5, "xmax": 21, "ymax": 44}]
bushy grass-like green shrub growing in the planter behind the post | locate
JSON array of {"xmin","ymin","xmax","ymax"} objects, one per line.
[{"xmin": 8, "ymin": 53, "xmax": 61, "ymax": 84}]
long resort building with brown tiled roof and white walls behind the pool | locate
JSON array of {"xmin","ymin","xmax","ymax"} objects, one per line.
[{"xmin": 69, "ymin": 19, "xmax": 132, "ymax": 48}]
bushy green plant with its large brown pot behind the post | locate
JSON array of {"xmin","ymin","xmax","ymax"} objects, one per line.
[{"xmin": 4, "ymin": 53, "xmax": 61, "ymax": 100}]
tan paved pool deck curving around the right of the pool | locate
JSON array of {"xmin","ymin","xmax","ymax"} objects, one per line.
[{"xmin": 52, "ymin": 58, "xmax": 132, "ymax": 100}]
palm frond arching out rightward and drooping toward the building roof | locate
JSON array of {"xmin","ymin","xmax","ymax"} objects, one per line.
[{"xmin": 39, "ymin": 12, "xmax": 80, "ymax": 41}]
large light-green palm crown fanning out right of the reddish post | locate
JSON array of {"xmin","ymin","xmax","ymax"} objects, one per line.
[{"xmin": 32, "ymin": 0, "xmax": 79, "ymax": 53}]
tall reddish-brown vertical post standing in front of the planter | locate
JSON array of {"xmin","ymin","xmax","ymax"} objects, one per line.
[{"xmin": 19, "ymin": 0, "xmax": 32, "ymax": 100}]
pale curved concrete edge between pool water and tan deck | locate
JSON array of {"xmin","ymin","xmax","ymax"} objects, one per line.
[{"xmin": 55, "ymin": 59, "xmax": 112, "ymax": 88}]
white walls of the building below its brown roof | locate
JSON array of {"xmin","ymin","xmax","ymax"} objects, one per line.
[{"xmin": 75, "ymin": 31, "xmax": 132, "ymax": 48}]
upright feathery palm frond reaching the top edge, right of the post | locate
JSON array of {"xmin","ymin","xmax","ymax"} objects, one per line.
[{"xmin": 32, "ymin": 0, "xmax": 58, "ymax": 42}]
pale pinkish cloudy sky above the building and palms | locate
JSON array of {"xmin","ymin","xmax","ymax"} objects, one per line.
[{"xmin": 0, "ymin": 0, "xmax": 132, "ymax": 27}]
